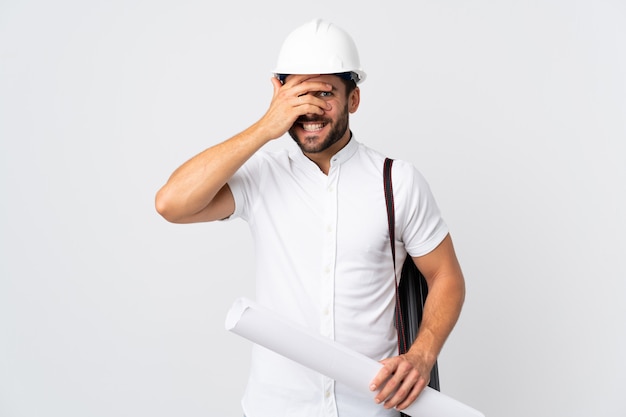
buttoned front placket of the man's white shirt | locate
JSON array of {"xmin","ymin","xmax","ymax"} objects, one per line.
[{"xmin": 320, "ymin": 159, "xmax": 340, "ymax": 417}]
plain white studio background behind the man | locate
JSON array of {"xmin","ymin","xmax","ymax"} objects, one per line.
[{"xmin": 0, "ymin": 0, "xmax": 626, "ymax": 417}]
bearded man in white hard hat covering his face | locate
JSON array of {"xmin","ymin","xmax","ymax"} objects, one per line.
[{"xmin": 156, "ymin": 20, "xmax": 465, "ymax": 417}]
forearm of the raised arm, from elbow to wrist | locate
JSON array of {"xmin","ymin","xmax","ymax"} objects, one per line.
[{"xmin": 155, "ymin": 123, "xmax": 270, "ymax": 222}]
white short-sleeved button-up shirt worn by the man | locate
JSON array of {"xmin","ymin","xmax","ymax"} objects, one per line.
[{"xmin": 228, "ymin": 137, "xmax": 448, "ymax": 417}]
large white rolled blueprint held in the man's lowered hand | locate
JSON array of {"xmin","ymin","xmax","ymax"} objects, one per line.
[{"xmin": 225, "ymin": 298, "xmax": 484, "ymax": 417}]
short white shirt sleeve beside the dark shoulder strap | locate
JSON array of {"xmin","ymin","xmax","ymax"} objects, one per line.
[{"xmin": 393, "ymin": 160, "xmax": 448, "ymax": 256}]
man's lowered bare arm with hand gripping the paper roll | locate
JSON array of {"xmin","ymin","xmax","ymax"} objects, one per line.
[{"xmin": 370, "ymin": 235, "xmax": 465, "ymax": 410}]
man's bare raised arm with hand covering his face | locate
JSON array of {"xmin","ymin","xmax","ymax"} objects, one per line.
[{"xmin": 155, "ymin": 76, "xmax": 332, "ymax": 223}]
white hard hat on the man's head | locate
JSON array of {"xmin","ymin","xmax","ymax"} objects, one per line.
[{"xmin": 274, "ymin": 19, "xmax": 365, "ymax": 83}]
